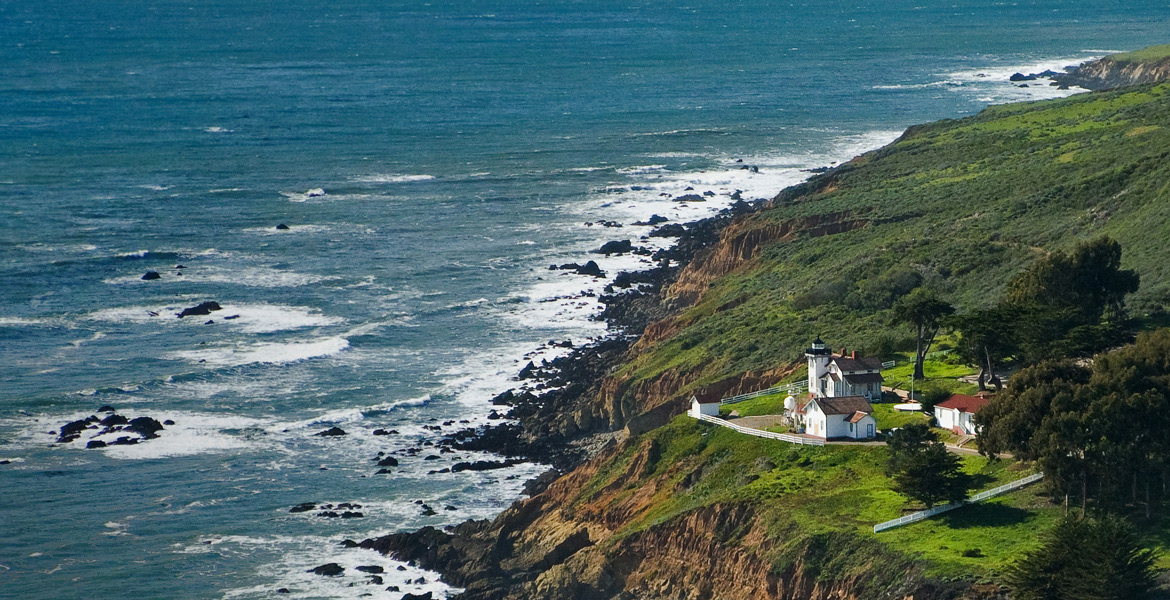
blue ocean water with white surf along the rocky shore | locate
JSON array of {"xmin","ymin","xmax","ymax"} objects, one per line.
[{"xmin": 0, "ymin": 0, "xmax": 1170, "ymax": 599}]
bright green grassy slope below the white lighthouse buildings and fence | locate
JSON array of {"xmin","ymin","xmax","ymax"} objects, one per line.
[{"xmin": 566, "ymin": 416, "xmax": 1170, "ymax": 580}]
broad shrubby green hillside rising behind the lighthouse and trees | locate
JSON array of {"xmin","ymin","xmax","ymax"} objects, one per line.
[{"xmin": 617, "ymin": 84, "xmax": 1170, "ymax": 408}]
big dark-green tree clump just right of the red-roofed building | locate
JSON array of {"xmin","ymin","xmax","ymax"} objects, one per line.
[{"xmin": 976, "ymin": 329, "xmax": 1170, "ymax": 518}]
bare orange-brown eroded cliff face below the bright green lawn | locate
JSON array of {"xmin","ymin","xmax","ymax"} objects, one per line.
[{"xmin": 362, "ymin": 439, "xmax": 999, "ymax": 600}]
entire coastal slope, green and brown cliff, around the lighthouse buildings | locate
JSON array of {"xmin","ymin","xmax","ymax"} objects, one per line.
[{"xmin": 383, "ymin": 70, "xmax": 1170, "ymax": 600}]
